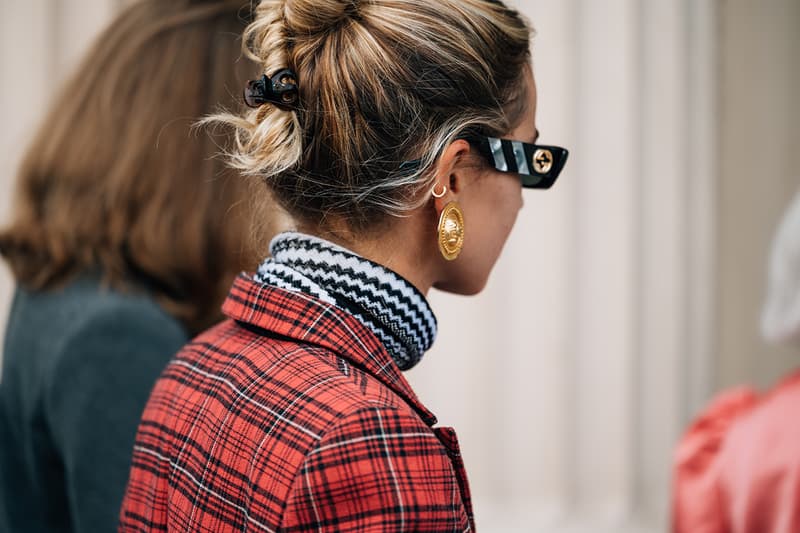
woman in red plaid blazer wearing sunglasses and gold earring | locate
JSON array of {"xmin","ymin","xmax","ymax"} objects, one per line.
[{"xmin": 120, "ymin": 0, "xmax": 566, "ymax": 531}]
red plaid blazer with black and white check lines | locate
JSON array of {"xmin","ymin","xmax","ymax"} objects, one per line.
[{"xmin": 119, "ymin": 275, "xmax": 474, "ymax": 532}]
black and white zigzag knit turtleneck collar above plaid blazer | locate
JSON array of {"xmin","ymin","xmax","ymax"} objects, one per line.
[{"xmin": 255, "ymin": 232, "xmax": 436, "ymax": 370}]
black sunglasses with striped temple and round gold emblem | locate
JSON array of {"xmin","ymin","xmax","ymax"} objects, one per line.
[{"xmin": 465, "ymin": 135, "xmax": 569, "ymax": 189}]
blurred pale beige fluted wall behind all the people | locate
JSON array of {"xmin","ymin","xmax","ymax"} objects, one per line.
[{"xmin": 0, "ymin": 0, "xmax": 800, "ymax": 533}]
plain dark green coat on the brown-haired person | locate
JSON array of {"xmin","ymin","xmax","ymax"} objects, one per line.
[{"xmin": 0, "ymin": 278, "xmax": 187, "ymax": 533}]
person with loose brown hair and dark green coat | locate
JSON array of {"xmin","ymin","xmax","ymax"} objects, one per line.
[{"xmin": 0, "ymin": 0, "xmax": 256, "ymax": 533}]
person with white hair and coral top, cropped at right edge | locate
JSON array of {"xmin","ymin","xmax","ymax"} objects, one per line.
[{"xmin": 673, "ymin": 189, "xmax": 800, "ymax": 533}]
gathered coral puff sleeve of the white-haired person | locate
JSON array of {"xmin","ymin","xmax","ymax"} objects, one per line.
[{"xmin": 672, "ymin": 387, "xmax": 759, "ymax": 533}]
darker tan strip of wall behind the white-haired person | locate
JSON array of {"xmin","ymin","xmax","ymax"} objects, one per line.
[{"xmin": 715, "ymin": 0, "xmax": 800, "ymax": 387}]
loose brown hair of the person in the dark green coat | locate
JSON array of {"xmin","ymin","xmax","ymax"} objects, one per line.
[{"xmin": 0, "ymin": 0, "xmax": 260, "ymax": 332}]
